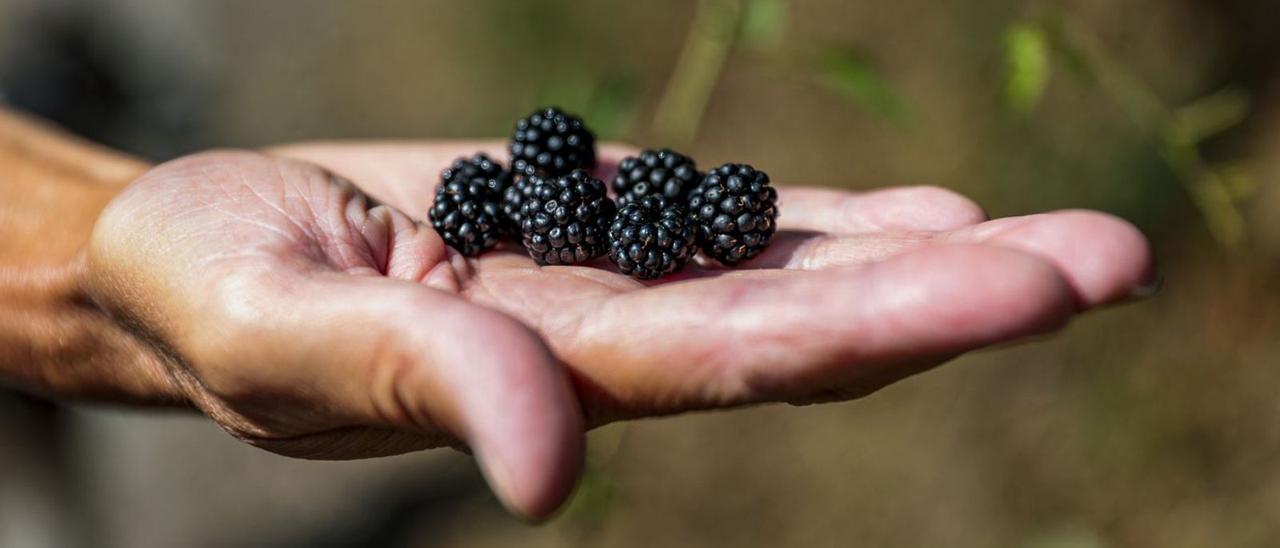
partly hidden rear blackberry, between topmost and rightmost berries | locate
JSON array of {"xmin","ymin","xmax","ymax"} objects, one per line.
[{"xmin": 613, "ymin": 149, "xmax": 703, "ymax": 207}]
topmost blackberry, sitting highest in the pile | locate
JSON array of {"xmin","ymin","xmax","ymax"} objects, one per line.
[{"xmin": 511, "ymin": 106, "xmax": 595, "ymax": 177}]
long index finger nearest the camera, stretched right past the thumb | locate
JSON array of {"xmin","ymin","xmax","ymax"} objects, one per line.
[{"xmin": 566, "ymin": 245, "xmax": 1074, "ymax": 414}]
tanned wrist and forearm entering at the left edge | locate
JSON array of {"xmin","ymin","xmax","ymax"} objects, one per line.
[{"xmin": 0, "ymin": 109, "xmax": 188, "ymax": 403}]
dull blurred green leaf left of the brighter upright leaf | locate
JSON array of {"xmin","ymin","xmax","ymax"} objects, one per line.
[{"xmin": 817, "ymin": 47, "xmax": 913, "ymax": 127}]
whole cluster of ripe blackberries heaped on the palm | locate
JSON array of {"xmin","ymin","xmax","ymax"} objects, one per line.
[{"xmin": 429, "ymin": 108, "xmax": 778, "ymax": 278}]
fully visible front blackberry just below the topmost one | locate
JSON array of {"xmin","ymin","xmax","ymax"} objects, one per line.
[{"xmin": 520, "ymin": 169, "xmax": 617, "ymax": 265}]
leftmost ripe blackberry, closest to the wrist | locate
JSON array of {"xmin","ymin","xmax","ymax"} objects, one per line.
[{"xmin": 428, "ymin": 177, "xmax": 502, "ymax": 256}]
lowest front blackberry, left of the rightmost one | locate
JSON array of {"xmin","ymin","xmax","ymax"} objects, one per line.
[{"xmin": 609, "ymin": 196, "xmax": 698, "ymax": 278}]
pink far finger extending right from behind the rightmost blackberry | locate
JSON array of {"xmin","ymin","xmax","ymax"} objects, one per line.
[{"xmin": 778, "ymin": 186, "xmax": 987, "ymax": 234}]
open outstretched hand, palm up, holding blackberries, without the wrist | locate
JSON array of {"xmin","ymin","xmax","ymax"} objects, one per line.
[{"xmin": 84, "ymin": 142, "xmax": 1151, "ymax": 517}]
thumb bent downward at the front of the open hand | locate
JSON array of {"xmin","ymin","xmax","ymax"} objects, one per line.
[{"xmin": 311, "ymin": 274, "xmax": 584, "ymax": 519}]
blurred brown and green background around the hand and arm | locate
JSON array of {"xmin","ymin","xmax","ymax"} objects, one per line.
[{"xmin": 0, "ymin": 0, "xmax": 1280, "ymax": 548}]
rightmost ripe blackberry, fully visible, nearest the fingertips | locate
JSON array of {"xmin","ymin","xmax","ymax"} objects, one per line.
[{"xmin": 689, "ymin": 164, "xmax": 778, "ymax": 266}]
